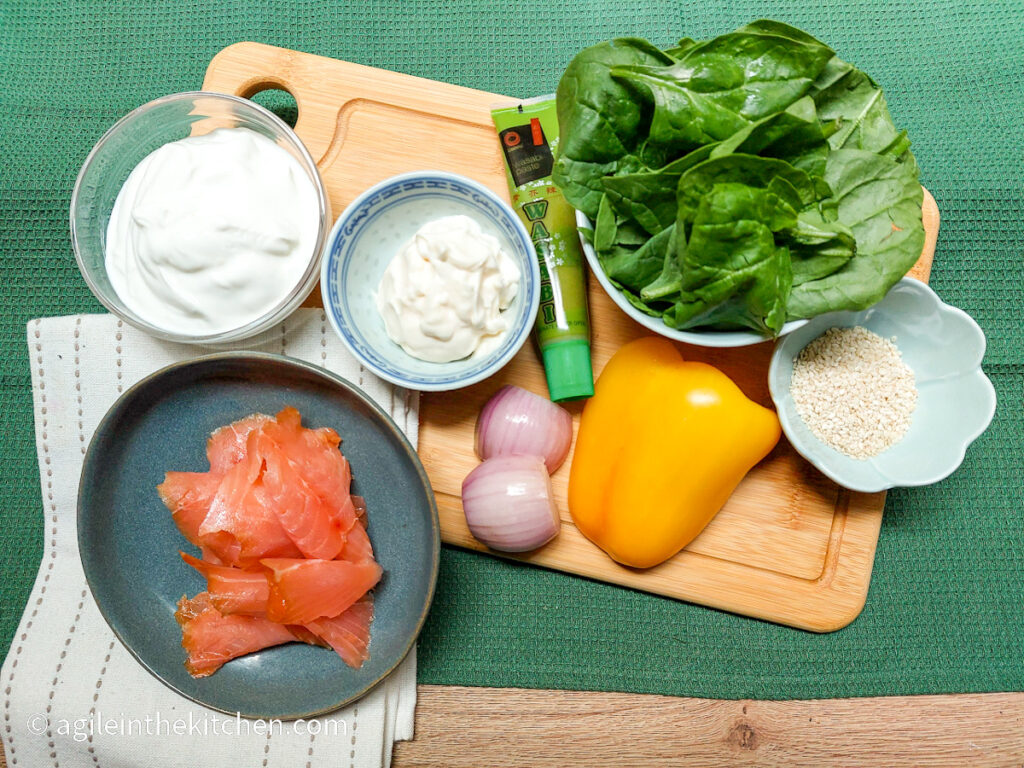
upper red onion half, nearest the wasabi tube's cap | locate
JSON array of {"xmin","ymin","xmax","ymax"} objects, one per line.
[{"xmin": 476, "ymin": 385, "xmax": 572, "ymax": 472}]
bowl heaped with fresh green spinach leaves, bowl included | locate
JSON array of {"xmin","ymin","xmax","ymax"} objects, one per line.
[{"xmin": 554, "ymin": 20, "xmax": 925, "ymax": 346}]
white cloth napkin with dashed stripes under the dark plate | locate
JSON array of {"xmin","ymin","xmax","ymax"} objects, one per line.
[{"xmin": 0, "ymin": 309, "xmax": 419, "ymax": 768}]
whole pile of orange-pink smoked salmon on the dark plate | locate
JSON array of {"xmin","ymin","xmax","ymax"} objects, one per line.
[{"xmin": 157, "ymin": 408, "xmax": 383, "ymax": 677}]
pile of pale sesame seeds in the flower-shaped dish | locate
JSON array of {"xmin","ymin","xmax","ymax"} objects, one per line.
[{"xmin": 790, "ymin": 327, "xmax": 918, "ymax": 460}]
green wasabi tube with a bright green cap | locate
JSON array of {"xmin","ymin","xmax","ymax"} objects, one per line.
[{"xmin": 490, "ymin": 96, "xmax": 594, "ymax": 402}]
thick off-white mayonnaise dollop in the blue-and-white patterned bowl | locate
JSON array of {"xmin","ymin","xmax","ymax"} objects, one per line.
[{"xmin": 376, "ymin": 215, "xmax": 520, "ymax": 362}]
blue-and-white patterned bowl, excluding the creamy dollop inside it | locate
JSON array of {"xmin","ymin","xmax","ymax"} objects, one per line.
[{"xmin": 321, "ymin": 171, "xmax": 541, "ymax": 390}]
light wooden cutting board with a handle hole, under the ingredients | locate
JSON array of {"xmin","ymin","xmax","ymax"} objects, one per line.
[{"xmin": 203, "ymin": 43, "xmax": 939, "ymax": 632}]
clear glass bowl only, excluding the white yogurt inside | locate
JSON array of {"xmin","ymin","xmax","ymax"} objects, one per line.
[{"xmin": 71, "ymin": 91, "xmax": 331, "ymax": 344}]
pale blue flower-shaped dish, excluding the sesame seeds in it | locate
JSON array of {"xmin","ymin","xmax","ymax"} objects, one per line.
[{"xmin": 768, "ymin": 278, "xmax": 995, "ymax": 493}]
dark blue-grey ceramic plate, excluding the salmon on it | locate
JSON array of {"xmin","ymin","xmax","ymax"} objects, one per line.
[{"xmin": 78, "ymin": 352, "xmax": 440, "ymax": 719}]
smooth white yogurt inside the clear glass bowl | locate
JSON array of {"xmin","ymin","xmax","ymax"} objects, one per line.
[{"xmin": 105, "ymin": 128, "xmax": 319, "ymax": 336}]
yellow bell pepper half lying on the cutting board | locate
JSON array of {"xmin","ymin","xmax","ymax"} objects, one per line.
[{"xmin": 569, "ymin": 337, "xmax": 781, "ymax": 568}]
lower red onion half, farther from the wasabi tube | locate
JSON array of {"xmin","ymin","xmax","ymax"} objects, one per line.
[{"xmin": 462, "ymin": 456, "xmax": 561, "ymax": 552}]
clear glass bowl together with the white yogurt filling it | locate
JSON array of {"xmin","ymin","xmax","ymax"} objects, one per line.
[{"xmin": 71, "ymin": 91, "xmax": 331, "ymax": 344}]
